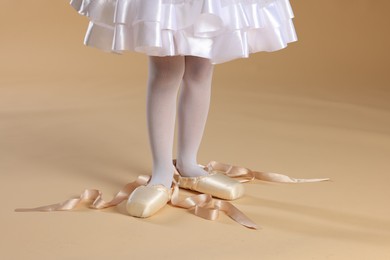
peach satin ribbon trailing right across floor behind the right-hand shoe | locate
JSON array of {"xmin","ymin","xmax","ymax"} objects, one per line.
[{"xmin": 199, "ymin": 161, "xmax": 330, "ymax": 183}]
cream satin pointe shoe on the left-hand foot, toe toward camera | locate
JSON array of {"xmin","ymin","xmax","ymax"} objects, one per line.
[{"xmin": 126, "ymin": 185, "xmax": 172, "ymax": 218}]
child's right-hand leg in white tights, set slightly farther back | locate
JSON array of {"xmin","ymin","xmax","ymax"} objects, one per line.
[{"xmin": 177, "ymin": 56, "xmax": 214, "ymax": 177}]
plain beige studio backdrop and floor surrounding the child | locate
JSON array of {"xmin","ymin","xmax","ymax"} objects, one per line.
[{"xmin": 0, "ymin": 0, "xmax": 390, "ymax": 259}]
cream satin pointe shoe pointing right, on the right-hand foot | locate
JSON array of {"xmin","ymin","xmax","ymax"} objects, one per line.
[{"xmin": 173, "ymin": 160, "xmax": 244, "ymax": 200}]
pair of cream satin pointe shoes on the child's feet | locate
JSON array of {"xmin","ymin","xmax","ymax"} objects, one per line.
[{"xmin": 126, "ymin": 160, "xmax": 244, "ymax": 218}]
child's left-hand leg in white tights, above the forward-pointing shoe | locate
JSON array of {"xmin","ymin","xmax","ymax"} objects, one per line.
[{"xmin": 146, "ymin": 56, "xmax": 184, "ymax": 188}]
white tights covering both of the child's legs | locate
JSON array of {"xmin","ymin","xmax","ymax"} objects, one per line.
[{"xmin": 146, "ymin": 56, "xmax": 213, "ymax": 187}]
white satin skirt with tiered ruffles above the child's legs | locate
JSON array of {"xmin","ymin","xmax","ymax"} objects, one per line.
[{"xmin": 70, "ymin": 0, "xmax": 297, "ymax": 64}]
